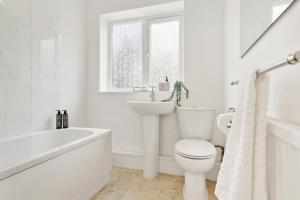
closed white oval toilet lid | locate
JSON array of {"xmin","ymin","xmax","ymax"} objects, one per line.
[{"xmin": 175, "ymin": 139, "xmax": 217, "ymax": 158}]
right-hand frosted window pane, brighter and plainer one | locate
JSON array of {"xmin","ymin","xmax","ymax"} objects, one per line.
[{"xmin": 149, "ymin": 21, "xmax": 180, "ymax": 85}]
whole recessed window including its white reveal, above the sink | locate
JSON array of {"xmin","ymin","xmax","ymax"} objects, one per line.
[{"xmin": 99, "ymin": 1, "xmax": 184, "ymax": 92}]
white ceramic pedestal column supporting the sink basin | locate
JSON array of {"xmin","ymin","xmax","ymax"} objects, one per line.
[{"xmin": 143, "ymin": 115, "xmax": 159, "ymax": 178}]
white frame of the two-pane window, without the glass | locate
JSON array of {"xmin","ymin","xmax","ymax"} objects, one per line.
[{"xmin": 106, "ymin": 12, "xmax": 184, "ymax": 92}]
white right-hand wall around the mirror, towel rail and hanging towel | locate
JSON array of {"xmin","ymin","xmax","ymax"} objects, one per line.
[{"xmin": 225, "ymin": 0, "xmax": 300, "ymax": 195}]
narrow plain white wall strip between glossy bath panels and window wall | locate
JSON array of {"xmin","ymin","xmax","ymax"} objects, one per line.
[{"xmin": 61, "ymin": 0, "xmax": 87, "ymax": 126}]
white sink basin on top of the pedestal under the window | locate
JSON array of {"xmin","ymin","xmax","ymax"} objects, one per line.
[{"xmin": 128, "ymin": 101, "xmax": 175, "ymax": 115}]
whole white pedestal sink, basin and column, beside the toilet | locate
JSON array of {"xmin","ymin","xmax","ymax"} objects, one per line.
[{"xmin": 128, "ymin": 101, "xmax": 175, "ymax": 178}]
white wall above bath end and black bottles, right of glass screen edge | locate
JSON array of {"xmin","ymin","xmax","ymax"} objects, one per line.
[{"xmin": 31, "ymin": 0, "xmax": 86, "ymax": 132}]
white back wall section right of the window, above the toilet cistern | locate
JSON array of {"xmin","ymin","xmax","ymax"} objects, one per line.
[{"xmin": 184, "ymin": 0, "xmax": 224, "ymax": 147}]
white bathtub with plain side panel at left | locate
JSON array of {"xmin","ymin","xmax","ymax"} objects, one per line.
[{"xmin": 0, "ymin": 128, "xmax": 112, "ymax": 200}]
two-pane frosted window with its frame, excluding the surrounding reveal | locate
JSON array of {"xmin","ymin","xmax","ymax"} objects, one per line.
[{"xmin": 107, "ymin": 16, "xmax": 182, "ymax": 90}]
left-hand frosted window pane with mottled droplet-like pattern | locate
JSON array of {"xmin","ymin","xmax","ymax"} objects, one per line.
[{"xmin": 111, "ymin": 22, "xmax": 143, "ymax": 88}]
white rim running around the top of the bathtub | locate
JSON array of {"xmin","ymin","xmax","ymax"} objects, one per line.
[{"xmin": 0, "ymin": 127, "xmax": 112, "ymax": 181}]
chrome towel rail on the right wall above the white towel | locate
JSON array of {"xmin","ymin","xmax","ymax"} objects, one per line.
[{"xmin": 256, "ymin": 51, "xmax": 300, "ymax": 76}]
